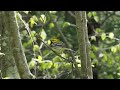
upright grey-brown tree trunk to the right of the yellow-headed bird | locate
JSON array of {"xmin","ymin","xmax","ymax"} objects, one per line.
[{"xmin": 75, "ymin": 11, "xmax": 93, "ymax": 79}]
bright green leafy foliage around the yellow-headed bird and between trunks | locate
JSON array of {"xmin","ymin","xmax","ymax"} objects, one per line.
[{"xmin": 18, "ymin": 11, "xmax": 120, "ymax": 79}]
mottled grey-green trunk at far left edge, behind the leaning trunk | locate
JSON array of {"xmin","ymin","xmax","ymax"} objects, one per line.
[{"xmin": 0, "ymin": 11, "xmax": 20, "ymax": 79}]
